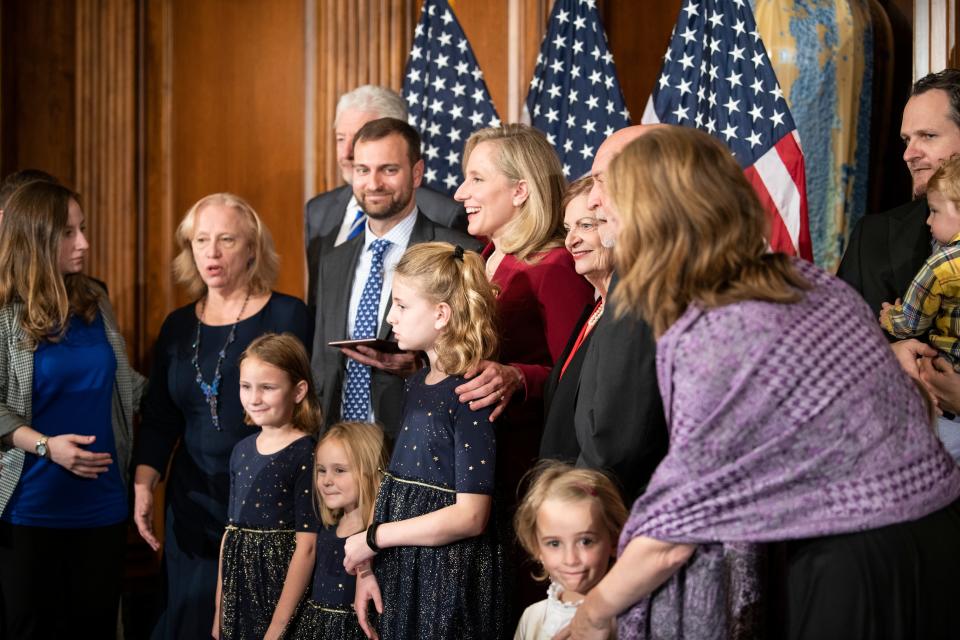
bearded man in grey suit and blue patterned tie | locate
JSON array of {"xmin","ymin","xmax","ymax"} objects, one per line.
[{"xmin": 312, "ymin": 118, "xmax": 480, "ymax": 441}]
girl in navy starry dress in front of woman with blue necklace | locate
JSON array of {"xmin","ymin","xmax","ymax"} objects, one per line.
[{"xmin": 212, "ymin": 333, "xmax": 320, "ymax": 639}]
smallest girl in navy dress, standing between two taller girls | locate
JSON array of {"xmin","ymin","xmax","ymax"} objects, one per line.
[{"xmin": 287, "ymin": 422, "xmax": 387, "ymax": 640}]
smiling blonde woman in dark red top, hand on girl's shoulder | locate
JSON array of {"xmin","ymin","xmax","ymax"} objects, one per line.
[{"xmin": 454, "ymin": 124, "xmax": 594, "ymax": 610}]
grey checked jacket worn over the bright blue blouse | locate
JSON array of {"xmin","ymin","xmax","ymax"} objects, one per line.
[{"xmin": 0, "ymin": 295, "xmax": 147, "ymax": 513}]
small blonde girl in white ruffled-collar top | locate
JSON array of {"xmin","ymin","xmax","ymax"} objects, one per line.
[{"xmin": 513, "ymin": 460, "xmax": 627, "ymax": 640}]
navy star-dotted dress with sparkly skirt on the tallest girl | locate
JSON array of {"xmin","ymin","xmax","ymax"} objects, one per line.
[{"xmin": 374, "ymin": 369, "xmax": 509, "ymax": 640}]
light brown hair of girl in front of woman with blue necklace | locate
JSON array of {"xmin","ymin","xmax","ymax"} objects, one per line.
[{"xmin": 237, "ymin": 333, "xmax": 323, "ymax": 434}]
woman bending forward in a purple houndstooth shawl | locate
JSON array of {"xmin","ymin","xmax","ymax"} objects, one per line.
[{"xmin": 557, "ymin": 127, "xmax": 960, "ymax": 640}]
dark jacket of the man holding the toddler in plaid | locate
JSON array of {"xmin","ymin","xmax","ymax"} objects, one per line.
[{"xmin": 837, "ymin": 198, "xmax": 933, "ymax": 316}]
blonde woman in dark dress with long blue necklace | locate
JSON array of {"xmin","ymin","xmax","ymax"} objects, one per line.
[{"xmin": 134, "ymin": 193, "xmax": 311, "ymax": 638}]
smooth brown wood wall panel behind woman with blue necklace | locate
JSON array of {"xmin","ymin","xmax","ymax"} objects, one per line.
[{"xmin": 142, "ymin": 0, "xmax": 305, "ymax": 346}]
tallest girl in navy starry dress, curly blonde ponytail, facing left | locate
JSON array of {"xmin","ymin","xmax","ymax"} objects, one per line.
[{"xmin": 344, "ymin": 242, "xmax": 508, "ymax": 640}]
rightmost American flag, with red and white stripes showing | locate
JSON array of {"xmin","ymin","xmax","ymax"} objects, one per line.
[{"xmin": 642, "ymin": 0, "xmax": 813, "ymax": 260}]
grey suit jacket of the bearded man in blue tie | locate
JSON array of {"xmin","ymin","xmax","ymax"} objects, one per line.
[{"xmin": 311, "ymin": 214, "xmax": 481, "ymax": 441}]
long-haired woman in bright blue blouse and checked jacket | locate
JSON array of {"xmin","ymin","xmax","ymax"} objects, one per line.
[{"xmin": 0, "ymin": 180, "xmax": 144, "ymax": 638}]
